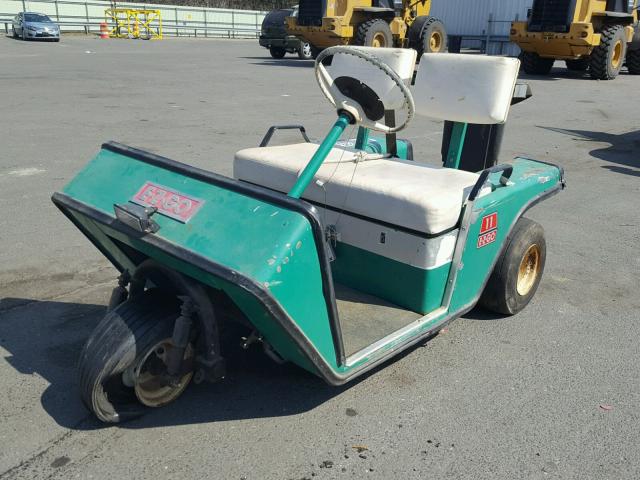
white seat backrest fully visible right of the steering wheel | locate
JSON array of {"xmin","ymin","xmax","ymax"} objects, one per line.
[{"xmin": 413, "ymin": 53, "xmax": 520, "ymax": 124}]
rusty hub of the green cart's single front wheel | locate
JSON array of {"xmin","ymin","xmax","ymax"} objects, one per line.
[{"xmin": 133, "ymin": 338, "xmax": 194, "ymax": 407}]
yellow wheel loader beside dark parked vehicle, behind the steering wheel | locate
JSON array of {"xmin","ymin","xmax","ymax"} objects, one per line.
[{"xmin": 286, "ymin": 0, "xmax": 447, "ymax": 57}]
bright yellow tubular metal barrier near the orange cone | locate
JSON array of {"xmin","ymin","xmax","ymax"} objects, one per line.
[{"xmin": 104, "ymin": 8, "xmax": 162, "ymax": 40}]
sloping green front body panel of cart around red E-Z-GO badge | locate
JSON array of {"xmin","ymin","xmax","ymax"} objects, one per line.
[{"xmin": 64, "ymin": 150, "xmax": 336, "ymax": 367}]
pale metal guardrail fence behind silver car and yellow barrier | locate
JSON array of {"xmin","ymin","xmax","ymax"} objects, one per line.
[{"xmin": 0, "ymin": 0, "xmax": 267, "ymax": 38}]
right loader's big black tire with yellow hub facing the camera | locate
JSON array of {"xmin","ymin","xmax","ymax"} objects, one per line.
[{"xmin": 589, "ymin": 25, "xmax": 627, "ymax": 80}]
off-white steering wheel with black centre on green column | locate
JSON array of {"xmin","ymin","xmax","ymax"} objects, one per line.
[{"xmin": 315, "ymin": 46, "xmax": 415, "ymax": 133}]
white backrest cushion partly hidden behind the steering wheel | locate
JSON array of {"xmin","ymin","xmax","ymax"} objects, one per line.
[{"xmin": 326, "ymin": 47, "xmax": 416, "ymax": 110}]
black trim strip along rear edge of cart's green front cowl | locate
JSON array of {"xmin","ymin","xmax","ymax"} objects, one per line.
[{"xmin": 102, "ymin": 142, "xmax": 346, "ymax": 365}]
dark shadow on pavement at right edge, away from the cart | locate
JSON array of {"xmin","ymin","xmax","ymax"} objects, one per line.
[{"xmin": 538, "ymin": 125, "xmax": 640, "ymax": 177}]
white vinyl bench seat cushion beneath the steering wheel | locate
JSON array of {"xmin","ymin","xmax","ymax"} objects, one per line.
[{"xmin": 233, "ymin": 143, "xmax": 478, "ymax": 234}]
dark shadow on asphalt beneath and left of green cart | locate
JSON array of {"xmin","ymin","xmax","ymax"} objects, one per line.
[{"xmin": 0, "ymin": 298, "xmax": 424, "ymax": 430}]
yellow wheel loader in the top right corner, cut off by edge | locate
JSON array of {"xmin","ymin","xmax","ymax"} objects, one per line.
[{"xmin": 511, "ymin": 0, "xmax": 640, "ymax": 80}]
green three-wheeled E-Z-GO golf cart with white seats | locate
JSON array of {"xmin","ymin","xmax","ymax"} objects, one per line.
[{"xmin": 53, "ymin": 47, "xmax": 564, "ymax": 422}]
